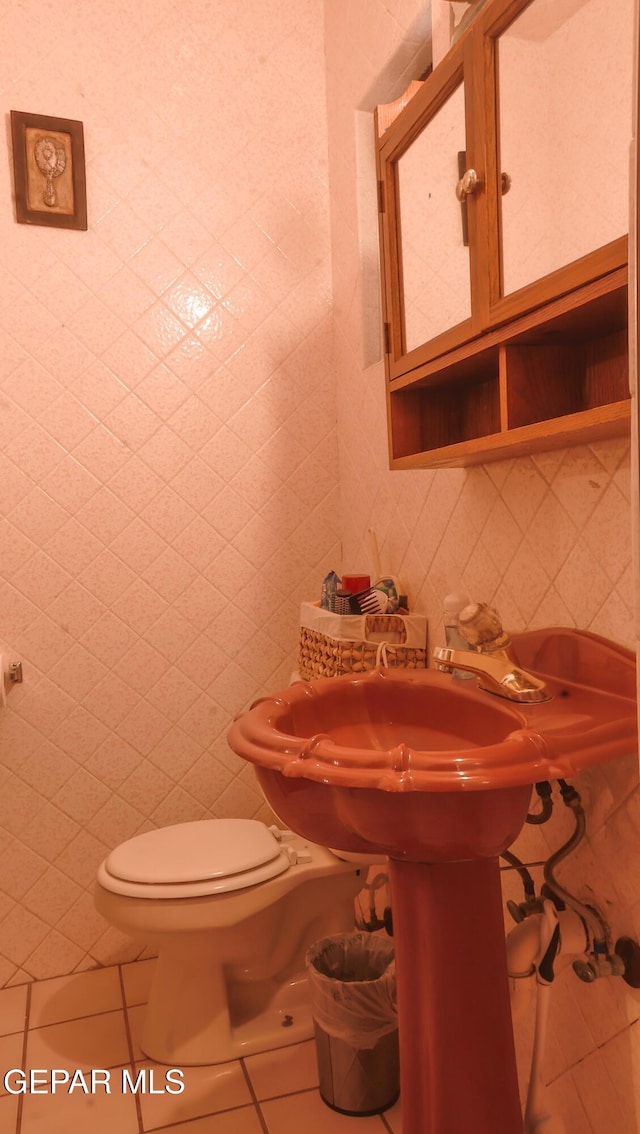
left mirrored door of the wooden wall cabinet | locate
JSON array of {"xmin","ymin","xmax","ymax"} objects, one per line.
[{"xmin": 378, "ymin": 35, "xmax": 486, "ymax": 379}]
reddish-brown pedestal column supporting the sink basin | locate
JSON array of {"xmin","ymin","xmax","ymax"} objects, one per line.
[{"xmin": 389, "ymin": 858, "xmax": 522, "ymax": 1134}]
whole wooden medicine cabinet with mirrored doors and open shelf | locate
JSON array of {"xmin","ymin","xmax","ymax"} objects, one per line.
[{"xmin": 377, "ymin": 0, "xmax": 633, "ymax": 468}]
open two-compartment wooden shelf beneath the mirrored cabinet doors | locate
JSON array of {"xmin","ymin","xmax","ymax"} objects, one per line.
[{"xmin": 388, "ymin": 269, "xmax": 630, "ymax": 468}]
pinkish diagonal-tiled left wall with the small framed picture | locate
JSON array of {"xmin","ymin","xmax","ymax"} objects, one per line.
[{"xmin": 0, "ymin": 0, "xmax": 339, "ymax": 984}]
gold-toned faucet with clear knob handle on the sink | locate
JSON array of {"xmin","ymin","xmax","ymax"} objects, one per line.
[{"xmin": 433, "ymin": 602, "xmax": 550, "ymax": 703}]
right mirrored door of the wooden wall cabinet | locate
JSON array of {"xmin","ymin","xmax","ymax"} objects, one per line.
[{"xmin": 482, "ymin": 0, "xmax": 633, "ymax": 323}]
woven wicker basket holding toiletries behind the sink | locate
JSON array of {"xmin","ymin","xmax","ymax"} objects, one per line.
[{"xmin": 298, "ymin": 615, "xmax": 427, "ymax": 682}]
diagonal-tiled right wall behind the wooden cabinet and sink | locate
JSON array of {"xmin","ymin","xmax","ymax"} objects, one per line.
[{"xmin": 326, "ymin": 0, "xmax": 640, "ymax": 1134}]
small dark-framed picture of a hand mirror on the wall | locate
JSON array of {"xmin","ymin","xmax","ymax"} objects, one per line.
[{"xmin": 11, "ymin": 110, "xmax": 87, "ymax": 229}]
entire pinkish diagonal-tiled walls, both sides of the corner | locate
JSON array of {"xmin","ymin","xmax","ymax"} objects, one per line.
[{"xmin": 0, "ymin": 0, "xmax": 640, "ymax": 1134}]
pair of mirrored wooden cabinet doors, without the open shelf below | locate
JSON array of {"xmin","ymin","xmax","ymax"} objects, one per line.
[{"xmin": 378, "ymin": 0, "xmax": 634, "ymax": 382}]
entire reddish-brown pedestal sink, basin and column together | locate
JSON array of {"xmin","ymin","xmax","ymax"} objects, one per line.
[{"xmin": 229, "ymin": 629, "xmax": 637, "ymax": 1134}]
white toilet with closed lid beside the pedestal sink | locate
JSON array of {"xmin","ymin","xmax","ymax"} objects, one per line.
[{"xmin": 94, "ymin": 819, "xmax": 369, "ymax": 1067}]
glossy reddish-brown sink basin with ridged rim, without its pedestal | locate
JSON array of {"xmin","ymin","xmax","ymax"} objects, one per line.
[{"xmin": 229, "ymin": 629, "xmax": 637, "ymax": 862}]
